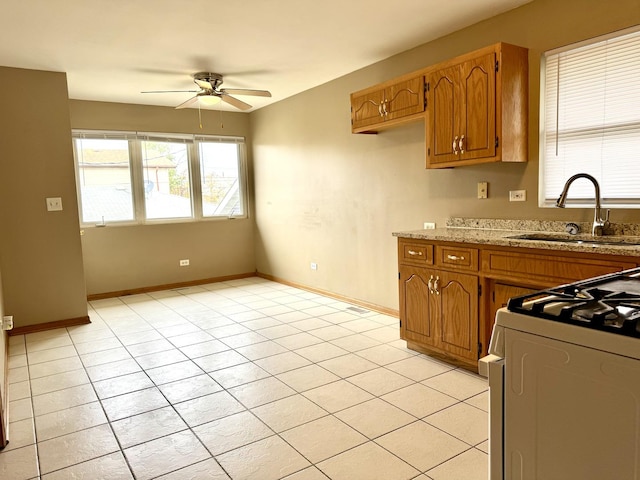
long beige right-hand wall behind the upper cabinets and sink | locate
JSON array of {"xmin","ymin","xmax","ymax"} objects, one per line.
[{"xmin": 251, "ymin": 0, "xmax": 640, "ymax": 309}]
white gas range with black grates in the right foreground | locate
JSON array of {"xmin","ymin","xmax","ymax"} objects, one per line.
[{"xmin": 479, "ymin": 269, "xmax": 640, "ymax": 480}]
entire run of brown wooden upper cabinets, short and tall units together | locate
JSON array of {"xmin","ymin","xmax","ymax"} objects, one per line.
[{"xmin": 351, "ymin": 43, "xmax": 529, "ymax": 168}]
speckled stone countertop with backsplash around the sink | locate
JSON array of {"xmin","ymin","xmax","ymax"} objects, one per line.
[{"xmin": 393, "ymin": 218, "xmax": 640, "ymax": 256}]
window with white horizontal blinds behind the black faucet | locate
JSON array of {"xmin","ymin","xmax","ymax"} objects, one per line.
[{"xmin": 539, "ymin": 25, "xmax": 640, "ymax": 208}]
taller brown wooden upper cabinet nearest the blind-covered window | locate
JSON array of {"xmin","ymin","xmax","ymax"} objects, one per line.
[{"xmin": 426, "ymin": 43, "xmax": 528, "ymax": 168}]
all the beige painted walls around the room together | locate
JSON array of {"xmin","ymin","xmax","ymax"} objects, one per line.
[{"xmin": 0, "ymin": 0, "xmax": 640, "ymax": 320}]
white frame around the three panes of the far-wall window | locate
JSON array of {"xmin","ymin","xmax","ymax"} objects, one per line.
[{"xmin": 71, "ymin": 129, "xmax": 249, "ymax": 228}]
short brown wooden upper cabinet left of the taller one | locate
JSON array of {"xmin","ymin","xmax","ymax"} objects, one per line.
[{"xmin": 351, "ymin": 74, "xmax": 425, "ymax": 133}]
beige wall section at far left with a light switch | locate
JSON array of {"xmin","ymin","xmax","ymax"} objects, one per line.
[{"xmin": 0, "ymin": 67, "xmax": 87, "ymax": 327}]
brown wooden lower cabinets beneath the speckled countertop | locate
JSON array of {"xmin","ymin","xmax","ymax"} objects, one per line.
[{"xmin": 398, "ymin": 237, "xmax": 639, "ymax": 371}]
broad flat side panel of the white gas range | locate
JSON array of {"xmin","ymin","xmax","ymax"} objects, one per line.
[{"xmin": 502, "ymin": 322, "xmax": 640, "ymax": 480}]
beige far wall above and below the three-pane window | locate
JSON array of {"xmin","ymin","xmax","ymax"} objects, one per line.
[{"xmin": 69, "ymin": 100, "xmax": 255, "ymax": 294}]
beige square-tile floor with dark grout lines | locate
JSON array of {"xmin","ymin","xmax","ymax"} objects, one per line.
[{"xmin": 0, "ymin": 278, "xmax": 488, "ymax": 480}]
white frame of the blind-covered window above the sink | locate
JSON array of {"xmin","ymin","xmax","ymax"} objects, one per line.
[{"xmin": 538, "ymin": 26, "xmax": 640, "ymax": 208}]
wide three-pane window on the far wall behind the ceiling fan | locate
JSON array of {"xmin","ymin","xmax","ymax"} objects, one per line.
[{"xmin": 73, "ymin": 130, "xmax": 246, "ymax": 225}]
